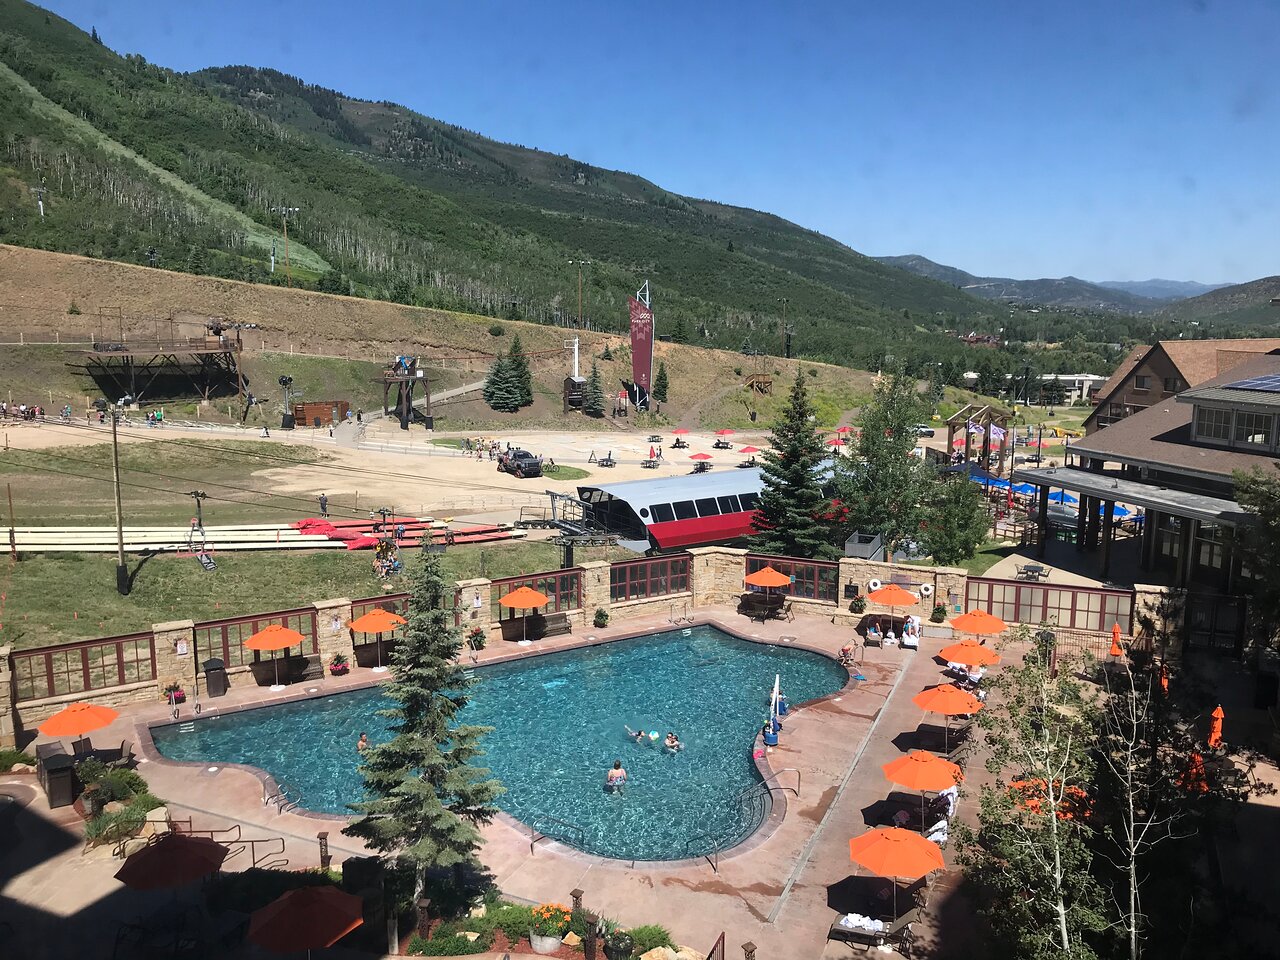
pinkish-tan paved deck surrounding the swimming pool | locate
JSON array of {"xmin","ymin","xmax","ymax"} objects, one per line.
[{"xmin": 0, "ymin": 607, "xmax": 952, "ymax": 960}]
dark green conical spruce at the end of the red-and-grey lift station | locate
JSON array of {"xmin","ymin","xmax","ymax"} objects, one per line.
[{"xmin": 755, "ymin": 374, "xmax": 837, "ymax": 558}]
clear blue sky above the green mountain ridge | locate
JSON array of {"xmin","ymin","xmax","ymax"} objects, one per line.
[{"xmin": 46, "ymin": 0, "xmax": 1280, "ymax": 282}]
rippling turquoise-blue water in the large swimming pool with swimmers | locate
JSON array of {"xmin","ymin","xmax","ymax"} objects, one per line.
[{"xmin": 152, "ymin": 626, "xmax": 849, "ymax": 860}]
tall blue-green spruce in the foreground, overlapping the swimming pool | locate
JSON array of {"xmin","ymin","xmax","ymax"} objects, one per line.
[{"xmin": 343, "ymin": 554, "xmax": 502, "ymax": 901}]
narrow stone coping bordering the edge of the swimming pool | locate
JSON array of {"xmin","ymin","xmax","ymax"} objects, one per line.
[{"xmin": 136, "ymin": 616, "xmax": 859, "ymax": 870}]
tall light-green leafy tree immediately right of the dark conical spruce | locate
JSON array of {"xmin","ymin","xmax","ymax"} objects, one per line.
[{"xmin": 837, "ymin": 365, "xmax": 936, "ymax": 557}]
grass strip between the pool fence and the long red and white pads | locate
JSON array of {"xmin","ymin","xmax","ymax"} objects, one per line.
[{"xmin": 0, "ymin": 540, "xmax": 632, "ymax": 648}]
